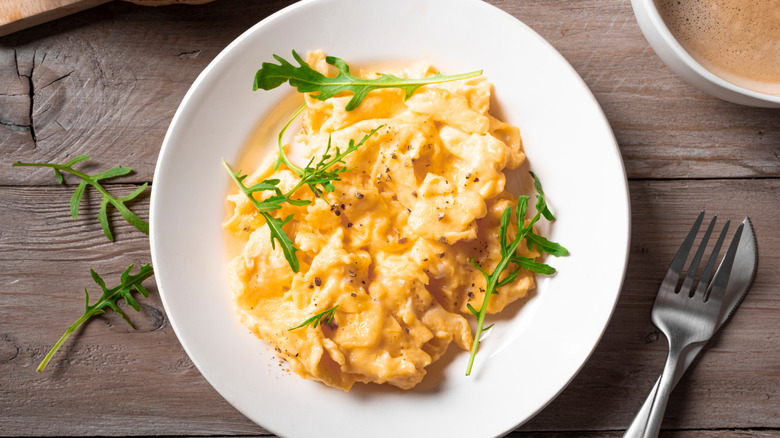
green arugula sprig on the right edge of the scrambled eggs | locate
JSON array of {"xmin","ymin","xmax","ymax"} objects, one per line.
[{"xmin": 466, "ymin": 172, "xmax": 569, "ymax": 376}]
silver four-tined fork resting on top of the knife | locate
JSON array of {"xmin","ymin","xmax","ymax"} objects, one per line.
[{"xmin": 642, "ymin": 211, "xmax": 743, "ymax": 437}]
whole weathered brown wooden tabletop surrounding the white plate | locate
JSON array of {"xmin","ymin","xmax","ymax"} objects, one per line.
[{"xmin": 0, "ymin": 0, "xmax": 780, "ymax": 437}]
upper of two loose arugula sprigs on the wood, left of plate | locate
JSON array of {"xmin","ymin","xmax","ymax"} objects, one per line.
[{"xmin": 13, "ymin": 155, "xmax": 149, "ymax": 242}]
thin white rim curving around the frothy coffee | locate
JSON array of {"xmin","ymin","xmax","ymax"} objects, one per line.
[{"xmin": 631, "ymin": 0, "xmax": 780, "ymax": 105}]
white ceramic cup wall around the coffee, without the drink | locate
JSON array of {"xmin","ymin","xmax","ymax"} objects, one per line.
[{"xmin": 631, "ymin": 0, "xmax": 780, "ymax": 108}]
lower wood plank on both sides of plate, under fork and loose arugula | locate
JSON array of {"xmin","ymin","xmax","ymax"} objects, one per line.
[{"xmin": 0, "ymin": 179, "xmax": 780, "ymax": 437}]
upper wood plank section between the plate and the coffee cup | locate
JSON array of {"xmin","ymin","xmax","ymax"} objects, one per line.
[{"xmin": 495, "ymin": 0, "xmax": 780, "ymax": 178}]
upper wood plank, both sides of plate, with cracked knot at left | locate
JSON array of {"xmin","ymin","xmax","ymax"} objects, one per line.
[{"xmin": 0, "ymin": 0, "xmax": 780, "ymax": 185}]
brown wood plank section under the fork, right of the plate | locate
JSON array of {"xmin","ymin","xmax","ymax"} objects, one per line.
[{"xmin": 523, "ymin": 180, "xmax": 780, "ymax": 430}]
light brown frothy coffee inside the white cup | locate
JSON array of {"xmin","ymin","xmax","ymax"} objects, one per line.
[{"xmin": 655, "ymin": 0, "xmax": 780, "ymax": 95}]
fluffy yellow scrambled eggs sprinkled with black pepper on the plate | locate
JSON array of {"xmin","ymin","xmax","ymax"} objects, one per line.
[{"xmin": 224, "ymin": 52, "xmax": 539, "ymax": 391}]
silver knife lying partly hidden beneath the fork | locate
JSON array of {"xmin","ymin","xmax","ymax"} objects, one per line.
[{"xmin": 624, "ymin": 218, "xmax": 758, "ymax": 437}]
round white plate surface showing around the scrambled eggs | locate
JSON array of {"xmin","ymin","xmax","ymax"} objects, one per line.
[{"xmin": 151, "ymin": 0, "xmax": 629, "ymax": 437}]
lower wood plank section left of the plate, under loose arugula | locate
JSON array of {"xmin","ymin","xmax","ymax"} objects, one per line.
[{"xmin": 0, "ymin": 185, "xmax": 262, "ymax": 436}]
